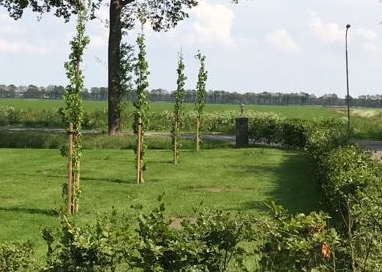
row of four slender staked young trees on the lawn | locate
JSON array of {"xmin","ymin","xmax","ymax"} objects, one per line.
[{"xmin": 59, "ymin": 0, "xmax": 207, "ymax": 211}]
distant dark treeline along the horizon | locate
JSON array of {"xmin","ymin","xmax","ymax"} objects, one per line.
[{"xmin": 0, "ymin": 84, "xmax": 382, "ymax": 107}]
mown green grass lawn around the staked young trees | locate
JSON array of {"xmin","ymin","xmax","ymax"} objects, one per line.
[{"xmin": 0, "ymin": 148, "xmax": 319, "ymax": 254}]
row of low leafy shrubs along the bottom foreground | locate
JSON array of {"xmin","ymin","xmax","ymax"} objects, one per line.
[{"xmin": 38, "ymin": 196, "xmax": 339, "ymax": 272}]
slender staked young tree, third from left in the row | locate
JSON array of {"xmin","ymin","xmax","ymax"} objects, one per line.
[{"xmin": 171, "ymin": 52, "xmax": 187, "ymax": 164}]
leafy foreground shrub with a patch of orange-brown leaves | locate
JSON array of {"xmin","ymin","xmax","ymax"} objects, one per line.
[{"xmin": 260, "ymin": 203, "xmax": 340, "ymax": 271}]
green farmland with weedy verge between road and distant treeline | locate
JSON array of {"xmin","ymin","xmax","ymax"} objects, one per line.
[{"xmin": 0, "ymin": 98, "xmax": 382, "ymax": 140}]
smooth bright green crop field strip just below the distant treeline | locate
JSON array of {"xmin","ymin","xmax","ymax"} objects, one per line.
[{"xmin": 0, "ymin": 98, "xmax": 344, "ymax": 120}]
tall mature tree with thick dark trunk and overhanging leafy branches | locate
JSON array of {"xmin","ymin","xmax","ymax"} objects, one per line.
[{"xmin": 0, "ymin": 0, "xmax": 198, "ymax": 134}]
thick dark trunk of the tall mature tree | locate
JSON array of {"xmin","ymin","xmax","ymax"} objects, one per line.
[{"xmin": 108, "ymin": 0, "xmax": 123, "ymax": 135}]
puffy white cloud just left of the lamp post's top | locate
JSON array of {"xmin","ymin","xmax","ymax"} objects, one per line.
[{"xmin": 309, "ymin": 16, "xmax": 345, "ymax": 43}]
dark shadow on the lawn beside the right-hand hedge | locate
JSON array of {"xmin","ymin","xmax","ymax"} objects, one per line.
[{"xmin": 240, "ymin": 152, "xmax": 320, "ymax": 213}]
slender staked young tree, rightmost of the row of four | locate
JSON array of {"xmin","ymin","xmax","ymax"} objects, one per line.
[{"xmin": 195, "ymin": 51, "xmax": 207, "ymax": 151}]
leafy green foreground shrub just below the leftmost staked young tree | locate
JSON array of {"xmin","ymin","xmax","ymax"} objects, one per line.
[{"xmin": 43, "ymin": 210, "xmax": 133, "ymax": 272}]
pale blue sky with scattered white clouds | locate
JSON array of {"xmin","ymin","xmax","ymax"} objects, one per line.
[{"xmin": 0, "ymin": 0, "xmax": 382, "ymax": 97}]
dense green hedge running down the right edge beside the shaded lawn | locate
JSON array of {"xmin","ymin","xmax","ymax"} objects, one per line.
[{"xmin": 307, "ymin": 118, "xmax": 382, "ymax": 271}]
